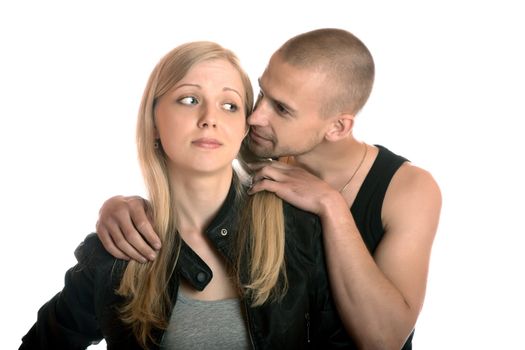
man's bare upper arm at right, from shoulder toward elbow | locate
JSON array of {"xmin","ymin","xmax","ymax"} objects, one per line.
[{"xmin": 374, "ymin": 166, "xmax": 441, "ymax": 317}]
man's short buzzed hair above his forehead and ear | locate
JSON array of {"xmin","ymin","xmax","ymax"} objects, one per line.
[{"xmin": 277, "ymin": 28, "xmax": 375, "ymax": 115}]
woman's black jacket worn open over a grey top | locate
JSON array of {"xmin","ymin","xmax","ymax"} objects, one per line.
[{"xmin": 20, "ymin": 186, "xmax": 354, "ymax": 349}]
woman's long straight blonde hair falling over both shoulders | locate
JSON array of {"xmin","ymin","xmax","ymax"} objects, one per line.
[{"xmin": 117, "ymin": 41, "xmax": 284, "ymax": 348}]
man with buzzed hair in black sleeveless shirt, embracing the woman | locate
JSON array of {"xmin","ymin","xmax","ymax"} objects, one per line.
[{"xmin": 97, "ymin": 29, "xmax": 441, "ymax": 349}]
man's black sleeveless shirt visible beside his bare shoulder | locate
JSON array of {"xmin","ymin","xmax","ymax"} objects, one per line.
[{"xmin": 350, "ymin": 145, "xmax": 414, "ymax": 350}]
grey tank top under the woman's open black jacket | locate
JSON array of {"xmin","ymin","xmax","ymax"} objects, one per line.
[{"xmin": 161, "ymin": 290, "xmax": 251, "ymax": 350}]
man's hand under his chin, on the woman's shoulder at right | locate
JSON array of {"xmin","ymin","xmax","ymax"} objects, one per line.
[{"xmin": 248, "ymin": 161, "xmax": 339, "ymax": 215}]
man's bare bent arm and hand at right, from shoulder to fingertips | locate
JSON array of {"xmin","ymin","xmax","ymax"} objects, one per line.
[{"xmin": 251, "ymin": 162, "xmax": 441, "ymax": 349}]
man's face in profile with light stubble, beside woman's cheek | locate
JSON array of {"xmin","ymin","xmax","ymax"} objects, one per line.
[{"xmin": 248, "ymin": 54, "xmax": 330, "ymax": 158}]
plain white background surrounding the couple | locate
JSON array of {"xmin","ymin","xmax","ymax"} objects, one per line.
[{"xmin": 0, "ymin": 0, "xmax": 525, "ymax": 349}]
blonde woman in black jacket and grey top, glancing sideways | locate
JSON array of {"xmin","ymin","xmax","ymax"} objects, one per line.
[{"xmin": 20, "ymin": 42, "xmax": 351, "ymax": 349}]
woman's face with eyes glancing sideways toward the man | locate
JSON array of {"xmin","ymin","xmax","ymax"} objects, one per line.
[{"xmin": 155, "ymin": 59, "xmax": 246, "ymax": 178}]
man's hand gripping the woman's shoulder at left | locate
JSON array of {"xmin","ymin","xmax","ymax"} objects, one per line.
[{"xmin": 96, "ymin": 196, "xmax": 161, "ymax": 263}]
